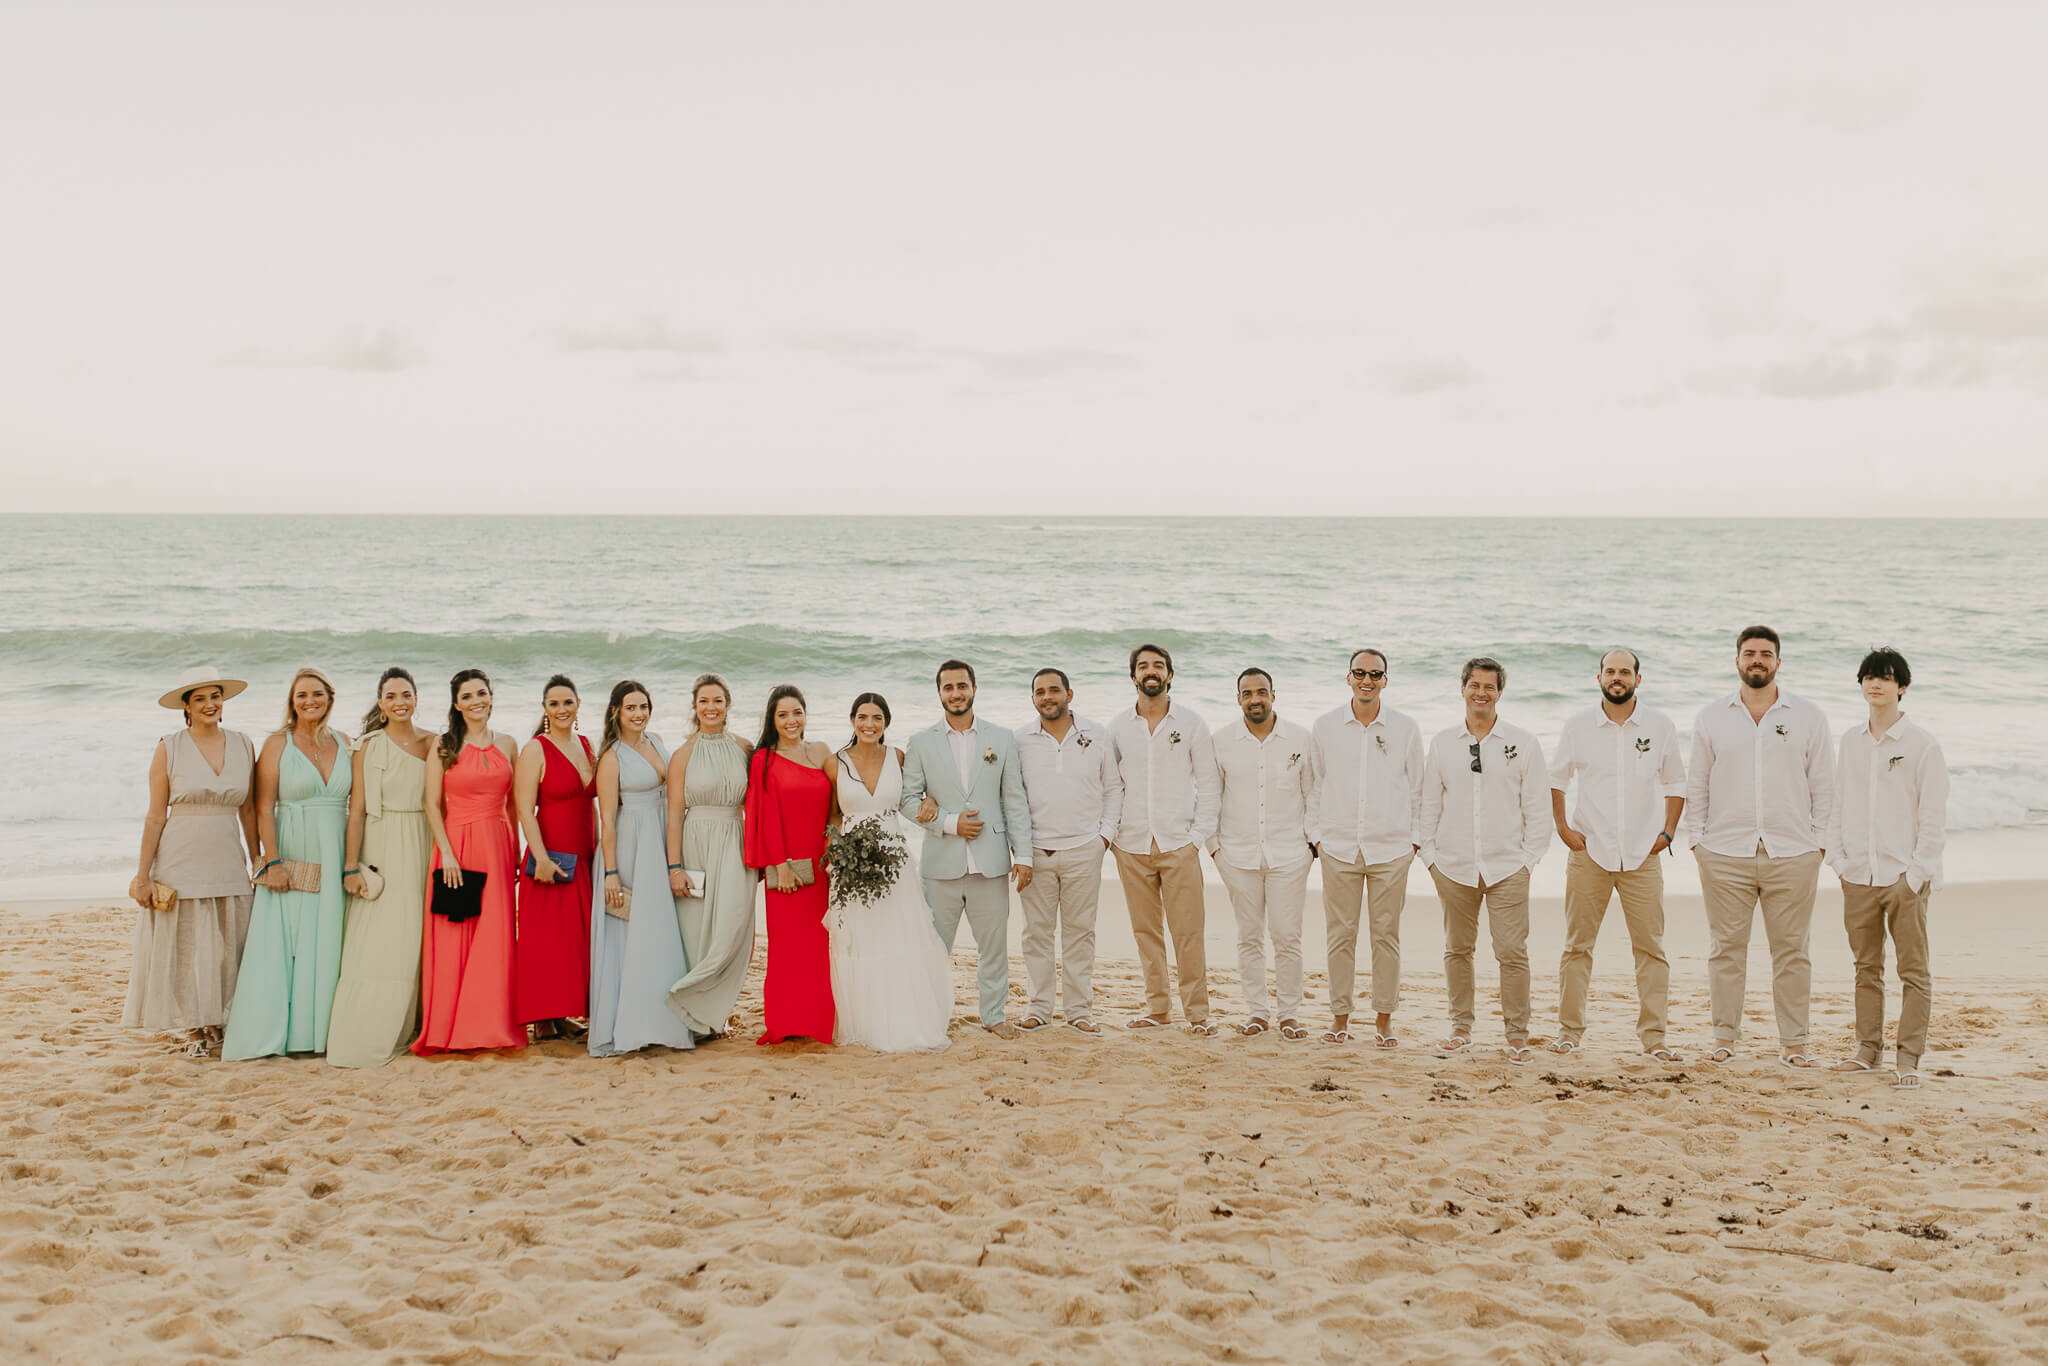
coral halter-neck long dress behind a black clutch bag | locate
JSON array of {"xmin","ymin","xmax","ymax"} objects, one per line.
[{"xmin": 412, "ymin": 745, "xmax": 526, "ymax": 1057}]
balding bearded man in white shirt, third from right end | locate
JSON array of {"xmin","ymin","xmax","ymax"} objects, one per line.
[{"xmin": 1550, "ymin": 647, "xmax": 1686, "ymax": 1063}]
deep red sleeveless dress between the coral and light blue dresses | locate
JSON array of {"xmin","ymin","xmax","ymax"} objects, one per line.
[{"xmin": 518, "ymin": 735, "xmax": 598, "ymax": 1024}]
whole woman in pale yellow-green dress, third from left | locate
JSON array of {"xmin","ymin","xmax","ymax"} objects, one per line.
[{"xmin": 328, "ymin": 668, "xmax": 434, "ymax": 1067}]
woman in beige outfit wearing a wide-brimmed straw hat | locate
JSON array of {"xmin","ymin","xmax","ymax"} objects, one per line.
[{"xmin": 121, "ymin": 668, "xmax": 262, "ymax": 1059}]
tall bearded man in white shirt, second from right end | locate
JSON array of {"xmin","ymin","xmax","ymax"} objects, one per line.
[{"xmin": 1686, "ymin": 627, "xmax": 1835, "ymax": 1067}]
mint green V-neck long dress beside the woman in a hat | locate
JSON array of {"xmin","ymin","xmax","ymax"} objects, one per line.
[{"xmin": 221, "ymin": 739, "xmax": 354, "ymax": 1059}]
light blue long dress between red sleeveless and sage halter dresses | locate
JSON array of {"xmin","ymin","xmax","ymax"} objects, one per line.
[{"xmin": 590, "ymin": 735, "xmax": 694, "ymax": 1057}]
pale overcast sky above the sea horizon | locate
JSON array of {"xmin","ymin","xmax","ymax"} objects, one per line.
[{"xmin": 0, "ymin": 0, "xmax": 2048, "ymax": 516}]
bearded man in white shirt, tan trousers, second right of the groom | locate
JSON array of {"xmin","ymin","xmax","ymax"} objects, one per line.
[{"xmin": 1110, "ymin": 643, "xmax": 1217, "ymax": 1038}]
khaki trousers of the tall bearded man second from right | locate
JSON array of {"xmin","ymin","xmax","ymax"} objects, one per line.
[{"xmin": 1692, "ymin": 842, "xmax": 1821, "ymax": 1049}]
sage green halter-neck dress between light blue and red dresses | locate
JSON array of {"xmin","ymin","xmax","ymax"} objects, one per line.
[{"xmin": 668, "ymin": 731, "xmax": 758, "ymax": 1036}]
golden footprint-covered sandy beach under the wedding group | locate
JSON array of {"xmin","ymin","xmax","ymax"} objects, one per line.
[{"xmin": 0, "ymin": 879, "xmax": 2048, "ymax": 1364}]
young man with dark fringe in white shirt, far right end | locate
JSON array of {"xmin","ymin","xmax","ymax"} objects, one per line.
[{"xmin": 1827, "ymin": 647, "xmax": 1948, "ymax": 1087}]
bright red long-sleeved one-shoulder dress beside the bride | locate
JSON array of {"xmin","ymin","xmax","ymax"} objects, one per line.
[{"xmin": 745, "ymin": 750, "xmax": 834, "ymax": 1044}]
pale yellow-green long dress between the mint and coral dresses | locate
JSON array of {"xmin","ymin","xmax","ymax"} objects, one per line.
[{"xmin": 328, "ymin": 731, "xmax": 434, "ymax": 1067}]
